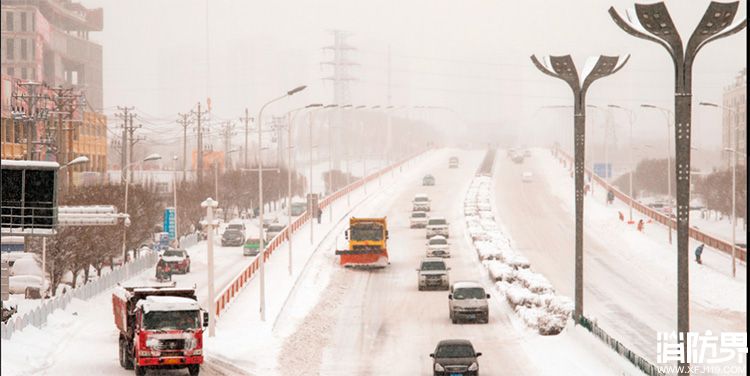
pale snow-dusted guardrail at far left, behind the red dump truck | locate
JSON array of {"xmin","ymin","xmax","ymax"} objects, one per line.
[{"xmin": 0, "ymin": 252, "xmax": 158, "ymax": 339}]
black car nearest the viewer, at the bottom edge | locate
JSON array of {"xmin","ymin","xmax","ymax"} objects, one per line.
[{"xmin": 430, "ymin": 339, "xmax": 482, "ymax": 376}]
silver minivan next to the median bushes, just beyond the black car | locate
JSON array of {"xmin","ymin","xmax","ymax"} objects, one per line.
[{"xmin": 448, "ymin": 281, "xmax": 490, "ymax": 324}]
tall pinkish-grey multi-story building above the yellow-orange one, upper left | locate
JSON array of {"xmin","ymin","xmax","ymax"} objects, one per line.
[{"xmin": 0, "ymin": 0, "xmax": 104, "ymax": 109}]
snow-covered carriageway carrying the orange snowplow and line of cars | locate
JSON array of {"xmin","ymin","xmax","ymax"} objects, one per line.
[{"xmin": 277, "ymin": 151, "xmax": 635, "ymax": 375}]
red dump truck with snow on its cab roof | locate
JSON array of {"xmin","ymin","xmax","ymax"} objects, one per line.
[{"xmin": 112, "ymin": 282, "xmax": 208, "ymax": 376}]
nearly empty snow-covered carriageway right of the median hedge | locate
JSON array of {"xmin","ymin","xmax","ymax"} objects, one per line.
[{"xmin": 494, "ymin": 149, "xmax": 747, "ymax": 372}]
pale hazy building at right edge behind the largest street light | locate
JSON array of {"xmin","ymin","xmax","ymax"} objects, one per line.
[{"xmin": 721, "ymin": 68, "xmax": 747, "ymax": 166}]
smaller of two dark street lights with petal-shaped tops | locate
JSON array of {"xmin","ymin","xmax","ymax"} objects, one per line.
[{"xmin": 531, "ymin": 55, "xmax": 630, "ymax": 322}]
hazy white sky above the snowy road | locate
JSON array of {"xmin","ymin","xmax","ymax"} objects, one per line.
[{"xmin": 83, "ymin": 0, "xmax": 747, "ymax": 151}]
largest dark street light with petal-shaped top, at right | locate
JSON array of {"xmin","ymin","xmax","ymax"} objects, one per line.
[{"xmin": 609, "ymin": 1, "xmax": 747, "ymax": 375}]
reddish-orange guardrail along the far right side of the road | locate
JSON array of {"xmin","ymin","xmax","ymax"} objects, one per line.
[{"xmin": 552, "ymin": 148, "xmax": 747, "ymax": 262}]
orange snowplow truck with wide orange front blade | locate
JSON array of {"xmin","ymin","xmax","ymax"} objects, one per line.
[{"xmin": 336, "ymin": 217, "xmax": 388, "ymax": 268}]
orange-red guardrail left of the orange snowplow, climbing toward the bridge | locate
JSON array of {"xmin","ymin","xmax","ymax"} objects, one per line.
[{"xmin": 214, "ymin": 152, "xmax": 423, "ymax": 317}]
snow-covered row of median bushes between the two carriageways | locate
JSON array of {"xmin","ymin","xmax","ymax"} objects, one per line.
[{"xmin": 464, "ymin": 176, "xmax": 573, "ymax": 335}]
